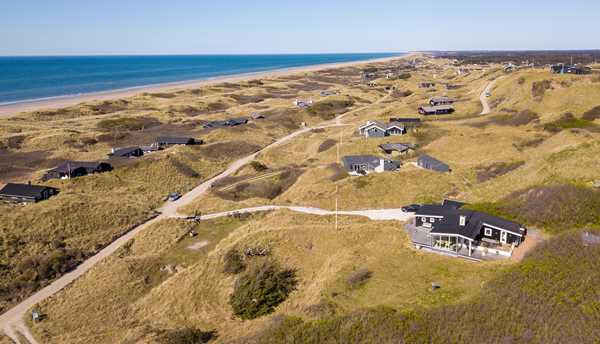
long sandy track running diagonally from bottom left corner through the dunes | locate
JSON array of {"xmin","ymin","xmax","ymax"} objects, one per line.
[{"xmin": 0, "ymin": 95, "xmax": 389, "ymax": 344}]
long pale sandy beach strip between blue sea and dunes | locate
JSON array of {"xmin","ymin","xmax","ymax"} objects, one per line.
[{"xmin": 0, "ymin": 53, "xmax": 415, "ymax": 118}]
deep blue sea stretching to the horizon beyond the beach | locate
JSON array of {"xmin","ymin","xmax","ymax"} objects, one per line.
[{"xmin": 0, "ymin": 53, "xmax": 402, "ymax": 105}]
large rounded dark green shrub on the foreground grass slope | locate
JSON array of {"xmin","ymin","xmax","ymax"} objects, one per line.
[{"xmin": 229, "ymin": 262, "xmax": 297, "ymax": 319}]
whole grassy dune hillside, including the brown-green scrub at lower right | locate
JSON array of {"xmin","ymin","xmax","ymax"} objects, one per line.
[{"xmin": 6, "ymin": 58, "xmax": 600, "ymax": 343}]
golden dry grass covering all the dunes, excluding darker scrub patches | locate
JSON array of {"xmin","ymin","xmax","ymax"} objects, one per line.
[{"xmin": 7, "ymin": 55, "xmax": 600, "ymax": 343}]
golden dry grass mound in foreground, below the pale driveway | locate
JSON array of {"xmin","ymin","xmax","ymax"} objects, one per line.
[{"xmin": 32, "ymin": 212, "xmax": 502, "ymax": 343}]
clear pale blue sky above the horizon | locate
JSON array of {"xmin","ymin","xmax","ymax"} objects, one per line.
[{"xmin": 0, "ymin": 0, "xmax": 600, "ymax": 55}]
